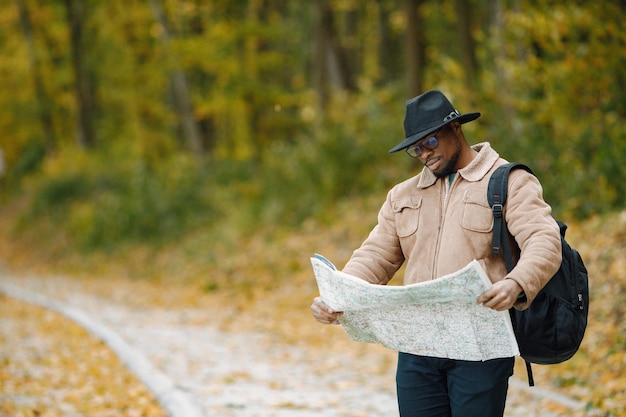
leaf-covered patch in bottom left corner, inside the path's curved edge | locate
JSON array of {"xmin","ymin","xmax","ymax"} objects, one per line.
[{"xmin": 0, "ymin": 296, "xmax": 165, "ymax": 417}]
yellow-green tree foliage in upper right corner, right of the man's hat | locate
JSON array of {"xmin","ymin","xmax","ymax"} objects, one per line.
[{"xmin": 472, "ymin": 2, "xmax": 626, "ymax": 218}]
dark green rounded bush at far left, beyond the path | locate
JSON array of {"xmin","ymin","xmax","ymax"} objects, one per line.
[{"xmin": 22, "ymin": 148, "xmax": 213, "ymax": 249}]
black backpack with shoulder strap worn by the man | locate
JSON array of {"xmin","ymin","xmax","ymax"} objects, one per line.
[{"xmin": 487, "ymin": 163, "xmax": 589, "ymax": 386}]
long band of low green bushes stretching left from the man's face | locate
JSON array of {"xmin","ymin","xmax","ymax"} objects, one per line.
[{"xmin": 14, "ymin": 87, "xmax": 414, "ymax": 249}]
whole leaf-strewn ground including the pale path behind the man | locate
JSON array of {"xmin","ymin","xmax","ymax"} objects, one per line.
[{"xmin": 0, "ymin": 201, "xmax": 626, "ymax": 417}]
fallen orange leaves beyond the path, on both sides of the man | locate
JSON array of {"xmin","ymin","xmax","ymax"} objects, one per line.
[{"xmin": 0, "ymin": 200, "xmax": 626, "ymax": 416}]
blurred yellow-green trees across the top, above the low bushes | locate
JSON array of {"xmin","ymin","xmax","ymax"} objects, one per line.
[{"xmin": 0, "ymin": 0, "xmax": 626, "ymax": 219}]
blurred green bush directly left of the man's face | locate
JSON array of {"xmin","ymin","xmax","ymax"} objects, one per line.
[{"xmin": 250, "ymin": 91, "xmax": 404, "ymax": 228}]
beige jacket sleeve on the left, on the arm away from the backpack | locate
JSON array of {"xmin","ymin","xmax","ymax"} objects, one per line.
[{"xmin": 343, "ymin": 192, "xmax": 404, "ymax": 285}]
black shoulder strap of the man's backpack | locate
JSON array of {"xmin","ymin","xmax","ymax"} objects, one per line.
[{"xmin": 487, "ymin": 162, "xmax": 534, "ymax": 272}]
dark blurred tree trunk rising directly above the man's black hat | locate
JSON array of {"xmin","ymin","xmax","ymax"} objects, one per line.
[{"xmin": 404, "ymin": 0, "xmax": 425, "ymax": 97}]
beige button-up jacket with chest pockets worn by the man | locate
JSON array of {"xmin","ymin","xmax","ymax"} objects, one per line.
[{"xmin": 343, "ymin": 142, "xmax": 561, "ymax": 309}]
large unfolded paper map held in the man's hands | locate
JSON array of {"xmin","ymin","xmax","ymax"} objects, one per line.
[{"xmin": 311, "ymin": 255, "xmax": 519, "ymax": 361}]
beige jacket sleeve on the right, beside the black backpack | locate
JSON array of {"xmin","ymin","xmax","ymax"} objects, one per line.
[{"xmin": 505, "ymin": 170, "xmax": 561, "ymax": 310}]
